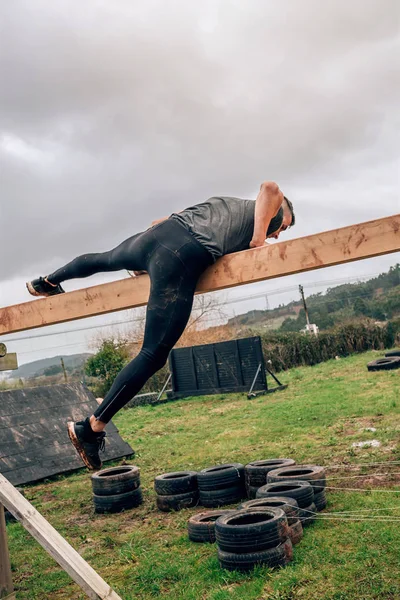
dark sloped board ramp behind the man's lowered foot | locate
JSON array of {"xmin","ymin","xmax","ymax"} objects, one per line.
[{"xmin": 0, "ymin": 383, "xmax": 133, "ymax": 485}]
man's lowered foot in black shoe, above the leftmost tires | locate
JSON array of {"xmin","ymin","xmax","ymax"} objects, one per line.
[{"xmin": 68, "ymin": 418, "xmax": 106, "ymax": 470}]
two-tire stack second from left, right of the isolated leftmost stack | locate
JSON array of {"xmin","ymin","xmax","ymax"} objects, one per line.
[{"xmin": 154, "ymin": 471, "xmax": 199, "ymax": 512}]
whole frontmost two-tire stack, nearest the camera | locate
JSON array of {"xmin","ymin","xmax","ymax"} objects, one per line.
[{"xmin": 215, "ymin": 508, "xmax": 293, "ymax": 571}]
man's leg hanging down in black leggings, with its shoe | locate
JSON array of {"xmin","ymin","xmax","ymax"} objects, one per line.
[{"xmin": 69, "ymin": 223, "xmax": 214, "ymax": 468}]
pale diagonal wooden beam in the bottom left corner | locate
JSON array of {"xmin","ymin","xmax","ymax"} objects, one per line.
[{"xmin": 0, "ymin": 474, "xmax": 122, "ymax": 600}]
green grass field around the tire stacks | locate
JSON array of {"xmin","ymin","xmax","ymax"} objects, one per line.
[{"xmin": 3, "ymin": 352, "xmax": 400, "ymax": 600}]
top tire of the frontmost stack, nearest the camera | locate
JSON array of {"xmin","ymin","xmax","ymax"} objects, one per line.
[{"xmin": 215, "ymin": 508, "xmax": 289, "ymax": 554}]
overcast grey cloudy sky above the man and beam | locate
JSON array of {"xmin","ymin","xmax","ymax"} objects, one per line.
[{"xmin": 0, "ymin": 0, "xmax": 400, "ymax": 364}]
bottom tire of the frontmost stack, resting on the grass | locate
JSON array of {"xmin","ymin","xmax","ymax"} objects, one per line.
[{"xmin": 218, "ymin": 538, "xmax": 293, "ymax": 572}]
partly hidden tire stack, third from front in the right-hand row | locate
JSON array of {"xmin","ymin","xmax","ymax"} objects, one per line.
[{"xmin": 257, "ymin": 480, "xmax": 316, "ymax": 527}]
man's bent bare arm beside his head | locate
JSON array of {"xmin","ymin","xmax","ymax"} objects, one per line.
[{"xmin": 250, "ymin": 181, "xmax": 283, "ymax": 248}]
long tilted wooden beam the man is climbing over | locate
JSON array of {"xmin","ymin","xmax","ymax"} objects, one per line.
[{"xmin": 0, "ymin": 214, "xmax": 400, "ymax": 335}]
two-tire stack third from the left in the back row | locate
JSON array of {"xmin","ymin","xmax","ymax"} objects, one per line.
[{"xmin": 197, "ymin": 463, "xmax": 246, "ymax": 508}]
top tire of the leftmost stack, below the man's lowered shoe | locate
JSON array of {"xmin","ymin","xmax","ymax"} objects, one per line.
[{"xmin": 91, "ymin": 465, "xmax": 140, "ymax": 496}]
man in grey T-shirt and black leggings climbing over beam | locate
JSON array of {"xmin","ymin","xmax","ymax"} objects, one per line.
[{"xmin": 27, "ymin": 181, "xmax": 295, "ymax": 469}]
